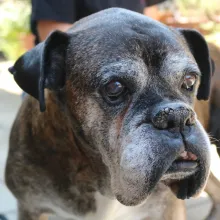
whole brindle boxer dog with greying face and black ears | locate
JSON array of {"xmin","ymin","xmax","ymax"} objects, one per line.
[{"xmin": 6, "ymin": 8, "xmax": 215, "ymax": 220}]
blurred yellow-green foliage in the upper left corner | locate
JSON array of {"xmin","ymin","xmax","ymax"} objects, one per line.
[{"xmin": 0, "ymin": 0, "xmax": 31, "ymax": 60}]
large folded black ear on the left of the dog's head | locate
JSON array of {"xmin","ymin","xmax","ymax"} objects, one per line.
[{"xmin": 9, "ymin": 31, "xmax": 69, "ymax": 111}]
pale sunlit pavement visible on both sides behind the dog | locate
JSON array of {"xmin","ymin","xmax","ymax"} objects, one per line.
[{"xmin": 0, "ymin": 62, "xmax": 215, "ymax": 220}]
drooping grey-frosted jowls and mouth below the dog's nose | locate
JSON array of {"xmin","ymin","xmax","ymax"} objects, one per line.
[{"xmin": 111, "ymin": 125, "xmax": 210, "ymax": 206}]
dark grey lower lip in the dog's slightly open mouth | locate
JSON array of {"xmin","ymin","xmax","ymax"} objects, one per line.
[{"xmin": 168, "ymin": 161, "xmax": 198, "ymax": 172}]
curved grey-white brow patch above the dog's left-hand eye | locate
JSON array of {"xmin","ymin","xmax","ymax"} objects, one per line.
[{"xmin": 99, "ymin": 58, "xmax": 148, "ymax": 89}]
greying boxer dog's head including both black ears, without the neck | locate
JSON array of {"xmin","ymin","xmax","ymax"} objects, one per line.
[{"xmin": 10, "ymin": 9, "xmax": 214, "ymax": 205}]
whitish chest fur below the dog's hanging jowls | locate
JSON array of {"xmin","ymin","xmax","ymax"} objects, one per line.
[{"xmin": 51, "ymin": 192, "xmax": 167, "ymax": 220}]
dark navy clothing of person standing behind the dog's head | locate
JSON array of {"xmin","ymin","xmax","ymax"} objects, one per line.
[{"xmin": 31, "ymin": 0, "xmax": 165, "ymax": 44}]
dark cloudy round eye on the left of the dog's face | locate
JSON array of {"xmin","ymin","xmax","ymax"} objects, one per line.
[{"xmin": 104, "ymin": 81, "xmax": 127, "ymax": 103}]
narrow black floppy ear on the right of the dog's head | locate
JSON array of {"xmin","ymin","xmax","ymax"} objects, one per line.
[{"xmin": 178, "ymin": 28, "xmax": 214, "ymax": 100}]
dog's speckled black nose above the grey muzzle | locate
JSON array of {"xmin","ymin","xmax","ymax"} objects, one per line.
[{"xmin": 152, "ymin": 103, "xmax": 195, "ymax": 130}]
